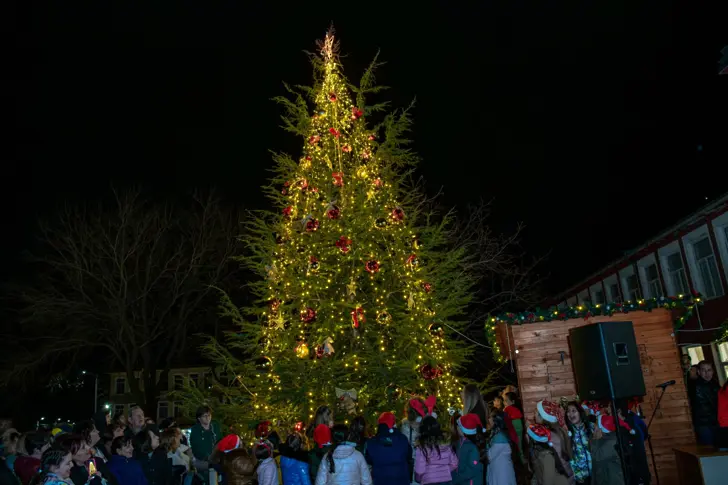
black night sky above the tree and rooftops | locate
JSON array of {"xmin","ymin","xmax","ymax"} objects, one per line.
[{"xmin": 7, "ymin": 1, "xmax": 728, "ymax": 293}]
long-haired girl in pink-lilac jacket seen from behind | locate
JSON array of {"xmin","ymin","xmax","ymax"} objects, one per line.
[{"xmin": 415, "ymin": 416, "xmax": 458, "ymax": 485}]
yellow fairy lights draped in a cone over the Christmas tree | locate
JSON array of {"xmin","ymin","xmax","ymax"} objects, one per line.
[{"xmin": 242, "ymin": 34, "xmax": 461, "ymax": 420}]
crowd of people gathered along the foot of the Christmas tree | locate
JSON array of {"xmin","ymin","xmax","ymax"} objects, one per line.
[{"xmin": 0, "ymin": 385, "xmax": 650, "ymax": 485}]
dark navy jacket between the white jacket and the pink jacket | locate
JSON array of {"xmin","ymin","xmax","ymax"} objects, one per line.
[{"xmin": 364, "ymin": 429, "xmax": 414, "ymax": 485}]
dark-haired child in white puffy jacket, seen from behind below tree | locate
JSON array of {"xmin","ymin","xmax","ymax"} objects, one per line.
[{"xmin": 314, "ymin": 425, "xmax": 372, "ymax": 485}]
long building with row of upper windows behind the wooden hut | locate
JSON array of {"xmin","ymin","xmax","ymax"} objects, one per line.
[{"xmin": 551, "ymin": 194, "xmax": 728, "ymax": 382}]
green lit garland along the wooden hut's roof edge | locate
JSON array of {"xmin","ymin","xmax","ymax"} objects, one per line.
[{"xmin": 485, "ymin": 292, "xmax": 704, "ymax": 363}]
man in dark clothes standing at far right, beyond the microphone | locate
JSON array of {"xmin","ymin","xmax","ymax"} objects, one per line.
[{"xmin": 690, "ymin": 360, "xmax": 720, "ymax": 446}]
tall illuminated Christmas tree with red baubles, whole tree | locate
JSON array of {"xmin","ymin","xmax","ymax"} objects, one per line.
[{"xmin": 198, "ymin": 32, "xmax": 478, "ymax": 432}]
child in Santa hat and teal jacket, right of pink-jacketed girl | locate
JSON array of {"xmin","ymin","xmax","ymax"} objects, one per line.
[{"xmin": 452, "ymin": 413, "xmax": 487, "ymax": 485}]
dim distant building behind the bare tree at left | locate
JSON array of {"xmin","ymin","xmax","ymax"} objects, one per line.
[{"xmin": 109, "ymin": 367, "xmax": 211, "ymax": 422}]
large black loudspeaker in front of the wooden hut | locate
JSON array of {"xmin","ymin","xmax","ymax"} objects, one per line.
[{"xmin": 569, "ymin": 322, "xmax": 646, "ymax": 401}]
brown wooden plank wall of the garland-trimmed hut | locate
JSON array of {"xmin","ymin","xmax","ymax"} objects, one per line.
[{"xmin": 498, "ymin": 309, "xmax": 695, "ymax": 485}]
